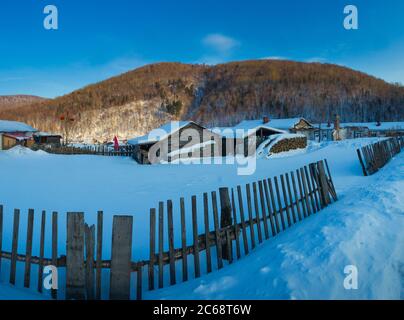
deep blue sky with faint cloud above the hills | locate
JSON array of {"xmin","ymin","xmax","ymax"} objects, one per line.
[{"xmin": 0, "ymin": 0, "xmax": 404, "ymax": 97}]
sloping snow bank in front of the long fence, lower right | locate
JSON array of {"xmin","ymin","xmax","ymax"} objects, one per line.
[{"xmin": 145, "ymin": 153, "xmax": 404, "ymax": 299}]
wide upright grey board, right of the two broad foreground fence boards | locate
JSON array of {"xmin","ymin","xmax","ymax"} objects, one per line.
[{"xmin": 109, "ymin": 216, "xmax": 133, "ymax": 300}]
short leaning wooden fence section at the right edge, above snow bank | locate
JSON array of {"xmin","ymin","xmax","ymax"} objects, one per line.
[{"xmin": 357, "ymin": 136, "xmax": 404, "ymax": 176}]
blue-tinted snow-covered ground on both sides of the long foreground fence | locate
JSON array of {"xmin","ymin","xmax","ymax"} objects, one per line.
[{"xmin": 0, "ymin": 139, "xmax": 404, "ymax": 299}]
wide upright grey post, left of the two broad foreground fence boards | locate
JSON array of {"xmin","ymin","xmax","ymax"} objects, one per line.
[{"xmin": 66, "ymin": 212, "xmax": 85, "ymax": 300}]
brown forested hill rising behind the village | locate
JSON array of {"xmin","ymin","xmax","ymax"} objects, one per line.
[{"xmin": 0, "ymin": 60, "xmax": 404, "ymax": 141}]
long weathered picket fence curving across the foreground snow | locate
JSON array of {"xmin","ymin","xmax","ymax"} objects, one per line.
[{"xmin": 0, "ymin": 160, "xmax": 337, "ymax": 300}]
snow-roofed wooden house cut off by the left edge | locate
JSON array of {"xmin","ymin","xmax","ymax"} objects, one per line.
[{"xmin": 0, "ymin": 120, "xmax": 38, "ymax": 150}]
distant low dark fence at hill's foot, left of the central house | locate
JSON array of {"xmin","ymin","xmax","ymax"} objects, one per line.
[{"xmin": 36, "ymin": 145, "xmax": 134, "ymax": 157}]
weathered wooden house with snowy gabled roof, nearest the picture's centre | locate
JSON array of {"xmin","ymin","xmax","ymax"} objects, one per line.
[{"xmin": 128, "ymin": 121, "xmax": 223, "ymax": 164}]
